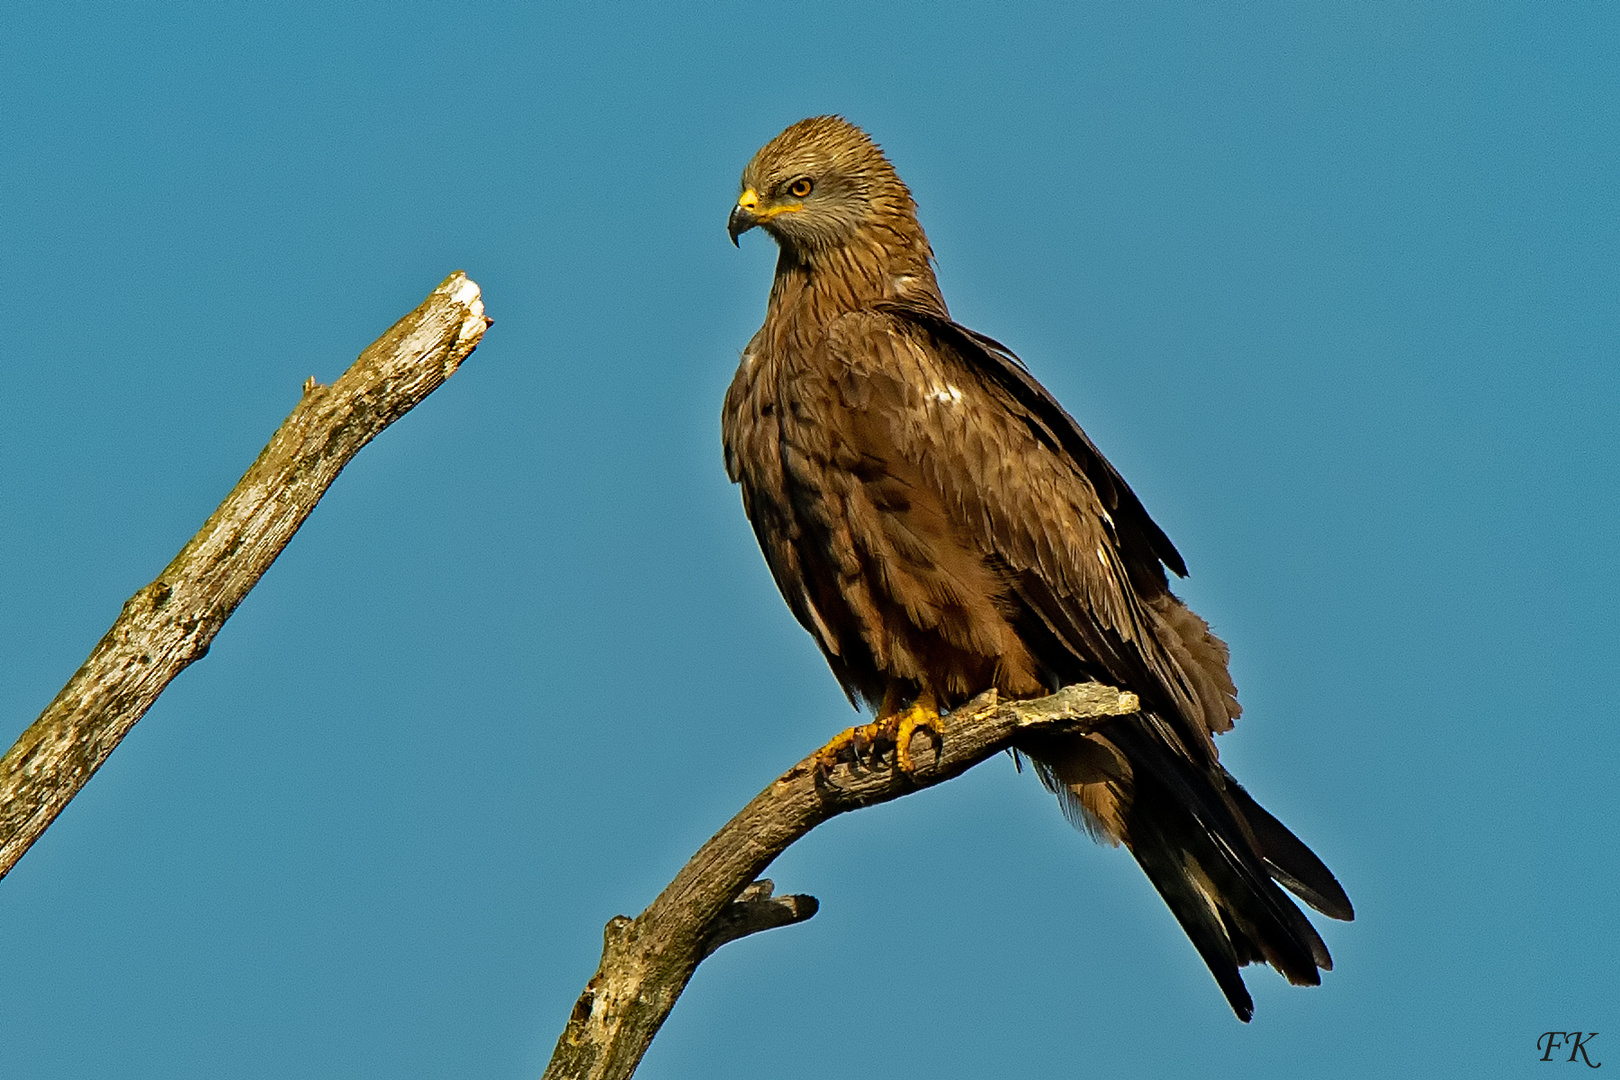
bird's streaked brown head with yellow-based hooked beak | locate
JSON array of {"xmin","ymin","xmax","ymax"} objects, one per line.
[{"xmin": 726, "ymin": 117, "xmax": 917, "ymax": 257}]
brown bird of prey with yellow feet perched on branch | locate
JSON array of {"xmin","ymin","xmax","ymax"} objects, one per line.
[{"xmin": 721, "ymin": 117, "xmax": 1353, "ymax": 1020}]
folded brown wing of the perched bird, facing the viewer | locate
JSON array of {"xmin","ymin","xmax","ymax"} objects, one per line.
[{"xmin": 826, "ymin": 304, "xmax": 1236, "ymax": 763}]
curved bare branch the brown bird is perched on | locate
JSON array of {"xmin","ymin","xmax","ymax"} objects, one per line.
[{"xmin": 544, "ymin": 683, "xmax": 1139, "ymax": 1080}]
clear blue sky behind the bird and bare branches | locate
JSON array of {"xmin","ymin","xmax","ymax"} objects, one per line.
[{"xmin": 0, "ymin": 0, "xmax": 1620, "ymax": 1080}]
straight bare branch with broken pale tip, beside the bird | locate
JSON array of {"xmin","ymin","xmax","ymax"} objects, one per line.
[{"xmin": 0, "ymin": 272, "xmax": 489, "ymax": 878}]
